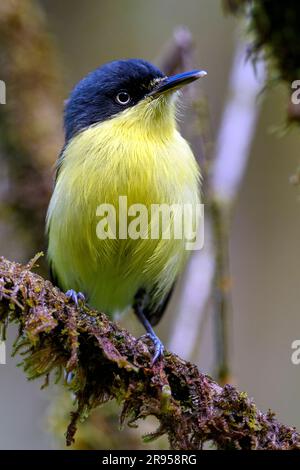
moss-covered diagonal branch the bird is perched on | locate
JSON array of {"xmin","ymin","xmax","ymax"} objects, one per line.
[{"xmin": 0, "ymin": 255, "xmax": 300, "ymax": 449}]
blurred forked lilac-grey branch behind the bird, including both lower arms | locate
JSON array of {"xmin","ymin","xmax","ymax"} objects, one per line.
[{"xmin": 170, "ymin": 35, "xmax": 265, "ymax": 383}]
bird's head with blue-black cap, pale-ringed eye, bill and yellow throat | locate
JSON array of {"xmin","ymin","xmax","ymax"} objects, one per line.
[{"xmin": 65, "ymin": 59, "xmax": 206, "ymax": 141}]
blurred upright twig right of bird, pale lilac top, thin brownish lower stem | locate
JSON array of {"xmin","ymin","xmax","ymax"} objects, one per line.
[{"xmin": 209, "ymin": 38, "xmax": 265, "ymax": 382}]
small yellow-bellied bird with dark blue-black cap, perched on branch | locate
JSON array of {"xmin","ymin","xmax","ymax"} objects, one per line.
[{"xmin": 46, "ymin": 59, "xmax": 206, "ymax": 364}]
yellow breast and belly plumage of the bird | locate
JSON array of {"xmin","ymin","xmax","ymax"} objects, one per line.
[{"xmin": 47, "ymin": 98, "xmax": 199, "ymax": 314}]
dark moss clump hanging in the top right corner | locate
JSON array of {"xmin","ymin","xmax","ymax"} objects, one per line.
[{"xmin": 223, "ymin": 0, "xmax": 300, "ymax": 122}]
